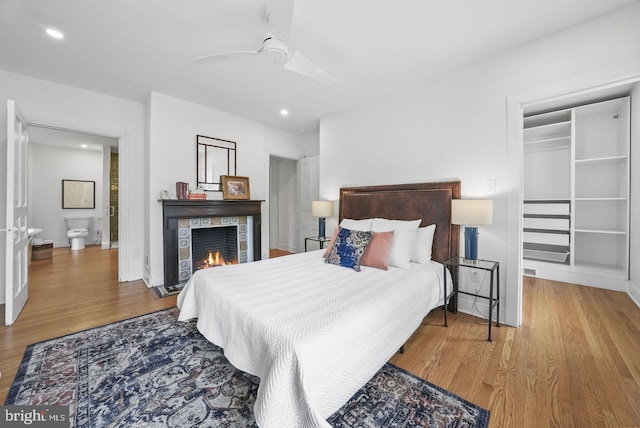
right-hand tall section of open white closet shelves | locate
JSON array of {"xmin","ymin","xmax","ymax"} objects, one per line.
[{"xmin": 574, "ymin": 98, "xmax": 630, "ymax": 274}]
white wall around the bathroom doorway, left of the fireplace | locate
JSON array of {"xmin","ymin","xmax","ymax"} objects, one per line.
[{"xmin": 0, "ymin": 70, "xmax": 146, "ymax": 281}]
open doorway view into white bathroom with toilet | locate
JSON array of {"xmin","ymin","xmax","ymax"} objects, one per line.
[{"xmin": 28, "ymin": 125, "xmax": 119, "ymax": 257}]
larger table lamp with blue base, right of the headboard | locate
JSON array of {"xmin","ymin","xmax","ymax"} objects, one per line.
[{"xmin": 451, "ymin": 199, "xmax": 493, "ymax": 260}]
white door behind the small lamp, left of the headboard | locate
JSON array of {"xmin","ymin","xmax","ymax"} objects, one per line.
[{"xmin": 298, "ymin": 156, "xmax": 320, "ymax": 251}]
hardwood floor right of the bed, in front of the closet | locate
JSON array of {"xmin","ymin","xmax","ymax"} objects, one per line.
[{"xmin": 392, "ymin": 277, "xmax": 640, "ymax": 427}]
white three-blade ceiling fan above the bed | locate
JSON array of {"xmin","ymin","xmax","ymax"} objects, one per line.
[{"xmin": 193, "ymin": 0, "xmax": 340, "ymax": 86}]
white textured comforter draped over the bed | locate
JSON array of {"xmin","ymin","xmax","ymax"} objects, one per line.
[{"xmin": 178, "ymin": 251, "xmax": 451, "ymax": 428}]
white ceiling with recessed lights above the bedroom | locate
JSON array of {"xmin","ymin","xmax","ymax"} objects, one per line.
[{"xmin": 0, "ymin": 0, "xmax": 637, "ymax": 131}]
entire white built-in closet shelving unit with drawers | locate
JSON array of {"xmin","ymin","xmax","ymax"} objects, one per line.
[{"xmin": 523, "ymin": 97, "xmax": 630, "ymax": 283}]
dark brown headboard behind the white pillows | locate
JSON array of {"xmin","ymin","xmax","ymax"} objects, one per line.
[{"xmin": 339, "ymin": 181, "xmax": 461, "ymax": 263}]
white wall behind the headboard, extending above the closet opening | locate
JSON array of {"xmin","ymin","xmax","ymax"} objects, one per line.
[{"xmin": 320, "ymin": 3, "xmax": 640, "ymax": 325}]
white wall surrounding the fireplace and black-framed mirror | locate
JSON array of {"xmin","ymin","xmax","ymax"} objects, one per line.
[{"xmin": 144, "ymin": 92, "xmax": 312, "ymax": 286}]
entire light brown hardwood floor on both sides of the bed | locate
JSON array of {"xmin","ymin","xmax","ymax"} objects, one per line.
[{"xmin": 0, "ymin": 247, "xmax": 640, "ymax": 427}]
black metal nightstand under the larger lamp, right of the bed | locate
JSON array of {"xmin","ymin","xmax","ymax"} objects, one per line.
[{"xmin": 443, "ymin": 257, "xmax": 500, "ymax": 342}]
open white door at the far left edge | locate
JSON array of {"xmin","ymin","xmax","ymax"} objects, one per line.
[{"xmin": 5, "ymin": 100, "xmax": 29, "ymax": 325}]
